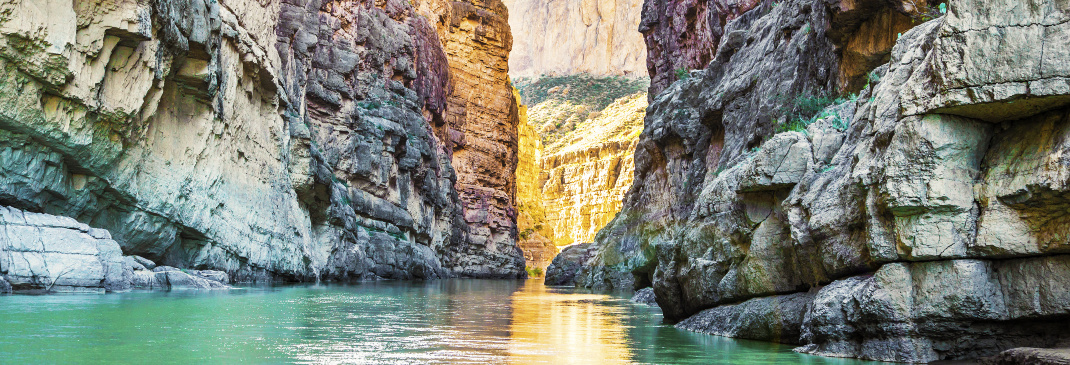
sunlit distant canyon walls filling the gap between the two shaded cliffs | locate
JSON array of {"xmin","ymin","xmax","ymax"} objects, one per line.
[{"xmin": 504, "ymin": 0, "xmax": 649, "ymax": 272}]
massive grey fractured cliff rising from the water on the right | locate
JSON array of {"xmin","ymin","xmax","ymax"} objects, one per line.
[{"xmin": 569, "ymin": 0, "xmax": 1070, "ymax": 362}]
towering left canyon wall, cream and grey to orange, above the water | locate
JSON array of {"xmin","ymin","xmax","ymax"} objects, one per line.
[{"xmin": 0, "ymin": 0, "xmax": 523, "ymax": 282}]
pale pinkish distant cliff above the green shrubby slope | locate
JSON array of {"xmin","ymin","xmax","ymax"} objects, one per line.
[{"xmin": 504, "ymin": 0, "xmax": 646, "ymax": 77}]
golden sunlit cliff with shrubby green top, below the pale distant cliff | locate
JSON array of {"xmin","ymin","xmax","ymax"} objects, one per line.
[{"xmin": 519, "ymin": 75, "xmax": 646, "ymax": 248}]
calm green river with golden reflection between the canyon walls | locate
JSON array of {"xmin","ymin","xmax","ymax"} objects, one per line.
[{"xmin": 0, "ymin": 280, "xmax": 877, "ymax": 364}]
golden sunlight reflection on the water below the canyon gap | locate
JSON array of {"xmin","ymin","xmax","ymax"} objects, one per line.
[{"xmin": 508, "ymin": 285, "xmax": 633, "ymax": 364}]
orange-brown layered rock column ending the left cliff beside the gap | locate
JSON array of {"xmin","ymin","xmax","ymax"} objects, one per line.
[{"xmin": 418, "ymin": 0, "xmax": 524, "ymax": 276}]
